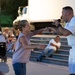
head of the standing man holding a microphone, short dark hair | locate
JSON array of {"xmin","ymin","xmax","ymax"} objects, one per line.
[{"xmin": 62, "ymin": 6, "xmax": 74, "ymax": 22}]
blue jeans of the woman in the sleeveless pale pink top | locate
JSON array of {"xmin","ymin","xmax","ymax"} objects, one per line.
[{"xmin": 13, "ymin": 63, "xmax": 26, "ymax": 75}]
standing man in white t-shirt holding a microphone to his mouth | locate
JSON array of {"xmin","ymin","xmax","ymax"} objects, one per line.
[{"xmin": 50, "ymin": 6, "xmax": 75, "ymax": 75}]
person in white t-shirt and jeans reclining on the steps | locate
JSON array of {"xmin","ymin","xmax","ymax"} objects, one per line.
[{"xmin": 37, "ymin": 36, "xmax": 61, "ymax": 61}]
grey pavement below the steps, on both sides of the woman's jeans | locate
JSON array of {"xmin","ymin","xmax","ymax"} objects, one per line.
[{"xmin": 0, "ymin": 58, "xmax": 69, "ymax": 75}]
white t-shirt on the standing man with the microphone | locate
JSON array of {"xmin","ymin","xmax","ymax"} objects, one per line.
[{"xmin": 65, "ymin": 17, "xmax": 75, "ymax": 47}]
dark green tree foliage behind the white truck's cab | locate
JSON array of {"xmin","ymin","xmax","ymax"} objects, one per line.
[{"xmin": 1, "ymin": 0, "xmax": 28, "ymax": 19}]
